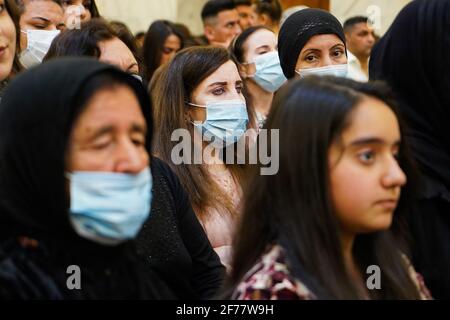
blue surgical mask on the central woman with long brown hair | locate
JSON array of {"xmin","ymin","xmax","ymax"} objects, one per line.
[{"xmin": 188, "ymin": 100, "xmax": 249, "ymax": 148}]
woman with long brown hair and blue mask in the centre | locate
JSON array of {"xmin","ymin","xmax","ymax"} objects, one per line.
[{"xmin": 150, "ymin": 47, "xmax": 253, "ymax": 264}]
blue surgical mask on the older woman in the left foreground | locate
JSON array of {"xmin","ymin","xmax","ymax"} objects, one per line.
[{"xmin": 67, "ymin": 168, "xmax": 152, "ymax": 245}]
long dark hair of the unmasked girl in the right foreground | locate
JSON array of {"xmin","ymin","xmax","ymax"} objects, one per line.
[{"xmin": 226, "ymin": 77, "xmax": 419, "ymax": 299}]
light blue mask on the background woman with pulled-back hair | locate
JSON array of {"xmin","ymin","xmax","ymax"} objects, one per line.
[{"xmin": 249, "ymin": 51, "xmax": 287, "ymax": 92}]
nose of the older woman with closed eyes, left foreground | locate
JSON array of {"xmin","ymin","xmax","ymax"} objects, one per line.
[{"xmin": 114, "ymin": 139, "xmax": 148, "ymax": 174}]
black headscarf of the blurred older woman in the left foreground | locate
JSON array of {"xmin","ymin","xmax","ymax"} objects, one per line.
[{"xmin": 0, "ymin": 58, "xmax": 171, "ymax": 298}]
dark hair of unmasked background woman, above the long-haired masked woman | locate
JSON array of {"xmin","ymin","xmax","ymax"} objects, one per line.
[{"xmin": 142, "ymin": 20, "xmax": 184, "ymax": 82}]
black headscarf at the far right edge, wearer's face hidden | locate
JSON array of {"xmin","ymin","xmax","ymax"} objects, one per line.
[{"xmin": 370, "ymin": 0, "xmax": 450, "ymax": 190}]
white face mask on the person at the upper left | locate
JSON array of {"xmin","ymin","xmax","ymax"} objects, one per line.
[{"xmin": 19, "ymin": 30, "xmax": 60, "ymax": 69}]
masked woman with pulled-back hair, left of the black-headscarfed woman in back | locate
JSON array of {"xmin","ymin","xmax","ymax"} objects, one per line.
[{"xmin": 230, "ymin": 26, "xmax": 286, "ymax": 127}]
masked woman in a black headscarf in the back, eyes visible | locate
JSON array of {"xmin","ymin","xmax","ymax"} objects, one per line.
[{"xmin": 278, "ymin": 9, "xmax": 348, "ymax": 79}]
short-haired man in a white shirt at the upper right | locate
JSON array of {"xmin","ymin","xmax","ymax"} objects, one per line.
[{"xmin": 344, "ymin": 16, "xmax": 375, "ymax": 82}]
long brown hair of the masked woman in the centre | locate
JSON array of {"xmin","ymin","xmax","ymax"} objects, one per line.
[{"xmin": 150, "ymin": 47, "xmax": 253, "ymax": 220}]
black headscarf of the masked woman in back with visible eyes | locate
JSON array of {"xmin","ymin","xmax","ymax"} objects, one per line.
[{"xmin": 278, "ymin": 9, "xmax": 345, "ymax": 79}]
